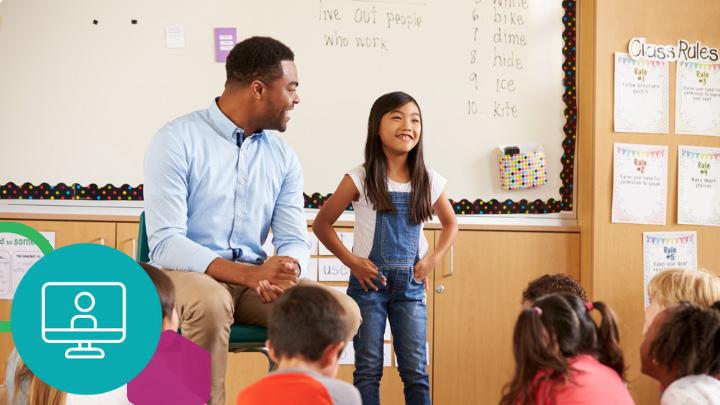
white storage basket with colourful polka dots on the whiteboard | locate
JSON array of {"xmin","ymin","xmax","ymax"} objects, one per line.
[{"xmin": 499, "ymin": 143, "xmax": 547, "ymax": 190}]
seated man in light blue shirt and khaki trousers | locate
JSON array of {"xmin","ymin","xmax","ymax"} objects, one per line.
[{"xmin": 145, "ymin": 37, "xmax": 360, "ymax": 405}]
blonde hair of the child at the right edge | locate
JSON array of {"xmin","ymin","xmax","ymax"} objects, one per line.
[{"xmin": 648, "ymin": 269, "xmax": 720, "ymax": 310}]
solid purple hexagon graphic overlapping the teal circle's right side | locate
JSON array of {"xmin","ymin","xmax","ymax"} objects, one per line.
[{"xmin": 128, "ymin": 330, "xmax": 210, "ymax": 405}]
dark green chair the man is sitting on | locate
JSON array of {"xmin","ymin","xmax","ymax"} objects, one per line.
[{"xmin": 135, "ymin": 212, "xmax": 275, "ymax": 371}]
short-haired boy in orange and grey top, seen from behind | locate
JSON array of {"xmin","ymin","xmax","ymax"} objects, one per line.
[{"xmin": 237, "ymin": 286, "xmax": 362, "ymax": 405}]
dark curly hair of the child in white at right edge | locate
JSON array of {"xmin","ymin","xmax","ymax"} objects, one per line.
[{"xmin": 649, "ymin": 301, "xmax": 720, "ymax": 378}]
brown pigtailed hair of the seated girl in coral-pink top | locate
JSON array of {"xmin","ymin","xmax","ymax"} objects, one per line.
[{"xmin": 500, "ymin": 294, "xmax": 625, "ymax": 405}]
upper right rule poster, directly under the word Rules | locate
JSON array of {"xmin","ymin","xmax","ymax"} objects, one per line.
[{"xmin": 675, "ymin": 61, "xmax": 720, "ymax": 136}]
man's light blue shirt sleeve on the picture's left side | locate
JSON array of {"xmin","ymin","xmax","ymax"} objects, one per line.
[{"xmin": 144, "ymin": 125, "xmax": 219, "ymax": 272}]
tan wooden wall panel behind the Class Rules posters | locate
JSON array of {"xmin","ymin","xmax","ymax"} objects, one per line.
[{"xmin": 579, "ymin": 0, "xmax": 720, "ymax": 404}]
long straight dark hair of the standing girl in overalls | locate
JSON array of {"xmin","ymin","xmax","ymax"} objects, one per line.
[{"xmin": 363, "ymin": 91, "xmax": 432, "ymax": 224}]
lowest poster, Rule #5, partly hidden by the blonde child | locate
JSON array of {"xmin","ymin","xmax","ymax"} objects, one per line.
[{"xmin": 643, "ymin": 232, "xmax": 697, "ymax": 306}]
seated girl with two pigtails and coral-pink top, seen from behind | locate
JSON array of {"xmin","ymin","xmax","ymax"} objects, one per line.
[{"xmin": 500, "ymin": 294, "xmax": 633, "ymax": 405}]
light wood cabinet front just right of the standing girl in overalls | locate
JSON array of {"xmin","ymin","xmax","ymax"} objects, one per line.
[{"xmin": 433, "ymin": 231, "xmax": 580, "ymax": 405}]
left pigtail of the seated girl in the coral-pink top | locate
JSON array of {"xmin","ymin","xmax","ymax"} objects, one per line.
[{"xmin": 500, "ymin": 306, "xmax": 569, "ymax": 405}]
